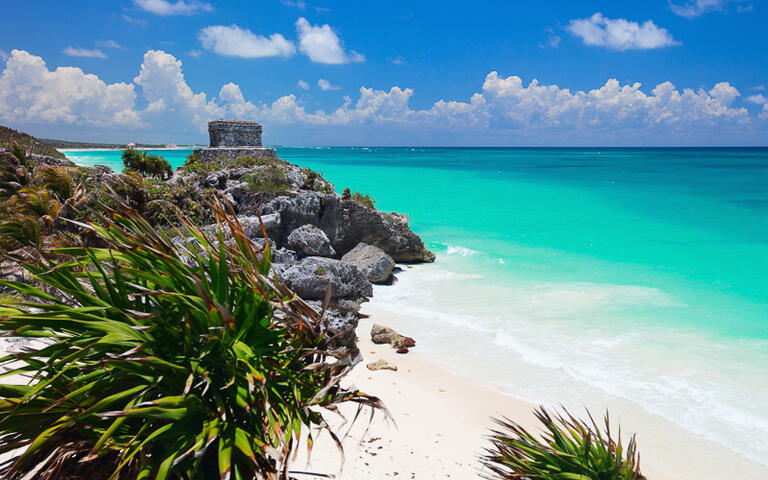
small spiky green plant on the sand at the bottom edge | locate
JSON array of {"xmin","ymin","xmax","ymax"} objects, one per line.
[{"xmin": 480, "ymin": 407, "xmax": 645, "ymax": 480}]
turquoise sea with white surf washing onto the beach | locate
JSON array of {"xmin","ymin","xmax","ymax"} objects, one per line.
[{"xmin": 67, "ymin": 148, "xmax": 768, "ymax": 478}]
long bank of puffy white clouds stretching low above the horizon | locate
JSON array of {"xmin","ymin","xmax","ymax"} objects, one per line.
[{"xmin": 0, "ymin": 50, "xmax": 768, "ymax": 146}]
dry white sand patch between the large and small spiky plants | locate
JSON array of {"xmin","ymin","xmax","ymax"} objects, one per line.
[{"xmin": 292, "ymin": 318, "xmax": 673, "ymax": 480}]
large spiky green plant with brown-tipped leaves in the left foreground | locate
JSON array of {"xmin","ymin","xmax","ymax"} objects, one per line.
[{"xmin": 0, "ymin": 200, "xmax": 383, "ymax": 480}]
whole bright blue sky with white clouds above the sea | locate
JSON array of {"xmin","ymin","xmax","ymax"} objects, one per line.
[{"xmin": 0, "ymin": 0, "xmax": 768, "ymax": 146}]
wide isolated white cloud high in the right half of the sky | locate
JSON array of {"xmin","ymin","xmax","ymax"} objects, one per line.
[{"xmin": 566, "ymin": 12, "xmax": 680, "ymax": 51}]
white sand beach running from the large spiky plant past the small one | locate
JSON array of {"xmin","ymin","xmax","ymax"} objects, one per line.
[{"xmin": 291, "ymin": 274, "xmax": 766, "ymax": 480}]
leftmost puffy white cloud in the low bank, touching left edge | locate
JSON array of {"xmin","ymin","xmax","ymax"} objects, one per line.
[{"xmin": 0, "ymin": 50, "xmax": 144, "ymax": 127}]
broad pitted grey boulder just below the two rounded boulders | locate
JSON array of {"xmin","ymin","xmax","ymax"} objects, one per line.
[{"xmin": 281, "ymin": 257, "xmax": 373, "ymax": 300}]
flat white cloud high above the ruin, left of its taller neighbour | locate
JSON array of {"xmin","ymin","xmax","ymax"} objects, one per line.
[{"xmin": 198, "ymin": 25, "xmax": 296, "ymax": 58}]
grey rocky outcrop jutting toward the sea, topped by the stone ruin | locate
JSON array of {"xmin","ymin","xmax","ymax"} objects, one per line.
[{"xmin": 177, "ymin": 121, "xmax": 435, "ymax": 351}]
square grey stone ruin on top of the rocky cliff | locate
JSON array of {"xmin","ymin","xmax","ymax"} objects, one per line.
[{"xmin": 193, "ymin": 120, "xmax": 277, "ymax": 162}]
